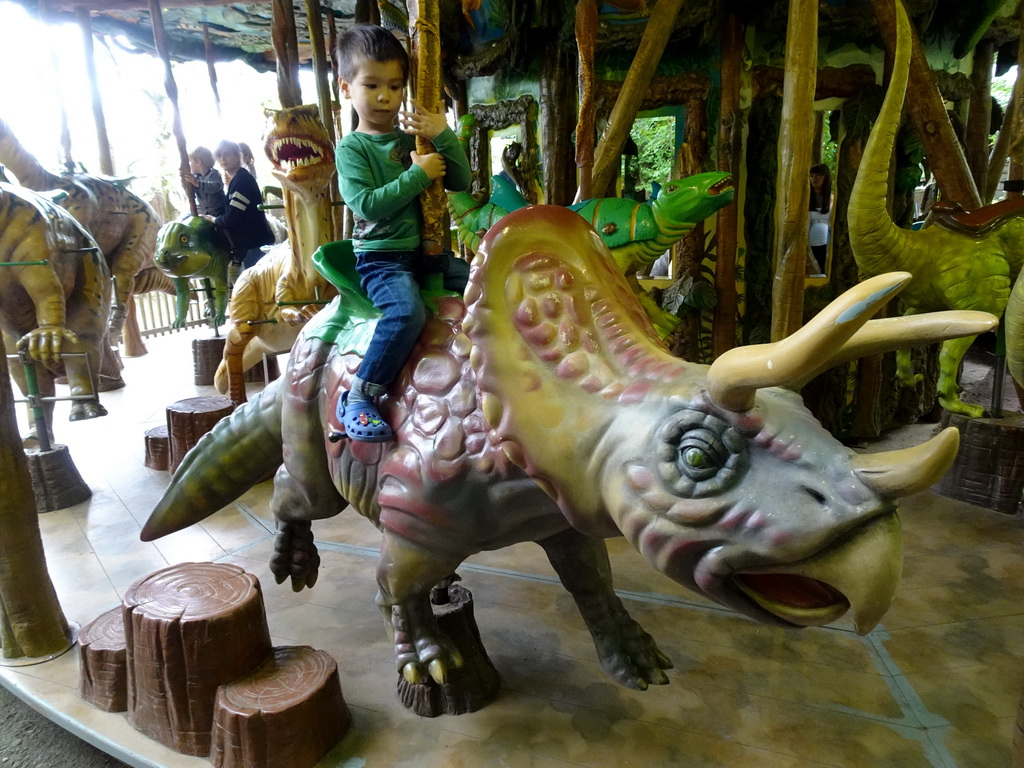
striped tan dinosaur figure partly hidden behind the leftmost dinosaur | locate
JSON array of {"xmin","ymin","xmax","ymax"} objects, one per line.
[{"xmin": 0, "ymin": 119, "xmax": 174, "ymax": 346}]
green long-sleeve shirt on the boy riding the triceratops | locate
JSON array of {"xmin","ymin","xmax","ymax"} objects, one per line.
[{"xmin": 335, "ymin": 128, "xmax": 471, "ymax": 251}]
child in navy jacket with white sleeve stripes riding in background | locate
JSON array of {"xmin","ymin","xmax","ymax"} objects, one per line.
[{"xmin": 207, "ymin": 141, "xmax": 273, "ymax": 269}]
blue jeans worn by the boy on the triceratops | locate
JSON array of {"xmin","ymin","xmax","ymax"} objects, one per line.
[{"xmin": 355, "ymin": 251, "xmax": 469, "ymax": 397}]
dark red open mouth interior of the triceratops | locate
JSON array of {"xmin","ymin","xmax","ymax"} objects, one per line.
[{"xmin": 733, "ymin": 573, "xmax": 850, "ymax": 627}]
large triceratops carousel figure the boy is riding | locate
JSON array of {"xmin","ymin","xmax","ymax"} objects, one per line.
[{"xmin": 142, "ymin": 206, "xmax": 995, "ymax": 688}]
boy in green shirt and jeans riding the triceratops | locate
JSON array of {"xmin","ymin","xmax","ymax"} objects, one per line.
[{"xmin": 336, "ymin": 25, "xmax": 470, "ymax": 442}]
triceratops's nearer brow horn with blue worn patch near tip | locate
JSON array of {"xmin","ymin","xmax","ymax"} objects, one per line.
[{"xmin": 708, "ymin": 272, "xmax": 910, "ymax": 411}]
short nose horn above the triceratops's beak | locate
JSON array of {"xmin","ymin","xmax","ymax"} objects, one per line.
[{"xmin": 852, "ymin": 427, "xmax": 959, "ymax": 499}]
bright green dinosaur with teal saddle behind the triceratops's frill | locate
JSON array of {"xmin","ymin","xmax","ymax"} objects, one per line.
[{"xmin": 449, "ymin": 171, "xmax": 734, "ymax": 338}]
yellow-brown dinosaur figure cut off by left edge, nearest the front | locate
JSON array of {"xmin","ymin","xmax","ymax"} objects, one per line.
[{"xmin": 0, "ymin": 183, "xmax": 111, "ymax": 436}]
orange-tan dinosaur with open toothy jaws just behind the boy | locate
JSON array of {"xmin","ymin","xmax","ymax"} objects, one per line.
[{"xmin": 214, "ymin": 104, "xmax": 337, "ymax": 403}]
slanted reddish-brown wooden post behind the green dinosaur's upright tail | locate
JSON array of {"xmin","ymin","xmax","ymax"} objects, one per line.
[{"xmin": 871, "ymin": 0, "xmax": 981, "ymax": 211}]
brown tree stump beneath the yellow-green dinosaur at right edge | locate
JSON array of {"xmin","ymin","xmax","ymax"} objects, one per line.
[{"xmin": 932, "ymin": 411, "xmax": 1024, "ymax": 515}]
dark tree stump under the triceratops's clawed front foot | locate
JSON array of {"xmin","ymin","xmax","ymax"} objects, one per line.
[{"xmin": 398, "ymin": 584, "xmax": 501, "ymax": 718}]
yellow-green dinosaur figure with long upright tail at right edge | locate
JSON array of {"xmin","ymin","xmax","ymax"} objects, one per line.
[{"xmin": 849, "ymin": 2, "xmax": 1024, "ymax": 418}]
